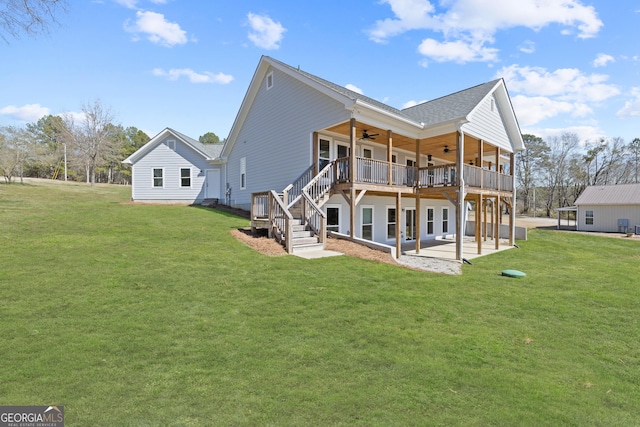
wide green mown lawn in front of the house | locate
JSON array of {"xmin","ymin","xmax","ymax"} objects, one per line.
[{"xmin": 0, "ymin": 183, "xmax": 640, "ymax": 426}]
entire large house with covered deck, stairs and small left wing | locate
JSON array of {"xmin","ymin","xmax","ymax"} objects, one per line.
[{"xmin": 127, "ymin": 56, "xmax": 524, "ymax": 259}]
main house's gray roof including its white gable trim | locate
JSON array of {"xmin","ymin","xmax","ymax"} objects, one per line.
[{"xmin": 221, "ymin": 56, "xmax": 524, "ymax": 157}]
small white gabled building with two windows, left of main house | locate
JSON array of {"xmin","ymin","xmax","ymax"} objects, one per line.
[{"xmin": 123, "ymin": 128, "xmax": 222, "ymax": 204}]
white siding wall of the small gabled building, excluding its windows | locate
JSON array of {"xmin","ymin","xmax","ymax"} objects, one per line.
[{"xmin": 131, "ymin": 136, "xmax": 214, "ymax": 203}]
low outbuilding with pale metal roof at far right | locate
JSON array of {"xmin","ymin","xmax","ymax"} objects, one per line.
[{"xmin": 575, "ymin": 184, "xmax": 640, "ymax": 233}]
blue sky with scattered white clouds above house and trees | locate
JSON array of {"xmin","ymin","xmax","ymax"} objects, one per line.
[{"xmin": 0, "ymin": 0, "xmax": 640, "ymax": 142}]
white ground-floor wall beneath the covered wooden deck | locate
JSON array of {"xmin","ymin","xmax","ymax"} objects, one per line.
[{"xmin": 323, "ymin": 195, "xmax": 455, "ymax": 246}]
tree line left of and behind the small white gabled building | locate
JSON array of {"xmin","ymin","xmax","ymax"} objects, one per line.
[{"xmin": 0, "ymin": 101, "xmax": 220, "ymax": 185}]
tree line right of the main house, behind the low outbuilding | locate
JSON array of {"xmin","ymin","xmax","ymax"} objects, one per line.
[{"xmin": 516, "ymin": 132, "xmax": 640, "ymax": 217}]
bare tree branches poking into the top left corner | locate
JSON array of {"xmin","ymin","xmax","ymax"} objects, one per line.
[{"xmin": 0, "ymin": 0, "xmax": 67, "ymax": 42}]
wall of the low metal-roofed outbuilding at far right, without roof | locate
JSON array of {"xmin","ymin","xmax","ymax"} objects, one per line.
[{"xmin": 576, "ymin": 205, "xmax": 640, "ymax": 233}]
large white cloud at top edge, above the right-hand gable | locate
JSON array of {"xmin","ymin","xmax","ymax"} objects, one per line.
[{"xmin": 368, "ymin": 0, "xmax": 603, "ymax": 62}]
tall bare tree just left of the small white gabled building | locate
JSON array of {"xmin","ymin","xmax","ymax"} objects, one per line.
[{"xmin": 63, "ymin": 100, "xmax": 118, "ymax": 186}]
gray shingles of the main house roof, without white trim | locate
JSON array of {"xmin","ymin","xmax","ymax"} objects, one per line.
[{"xmin": 269, "ymin": 57, "xmax": 501, "ymax": 126}]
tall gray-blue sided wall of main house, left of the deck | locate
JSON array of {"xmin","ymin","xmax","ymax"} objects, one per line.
[{"xmin": 226, "ymin": 68, "xmax": 350, "ymax": 210}]
